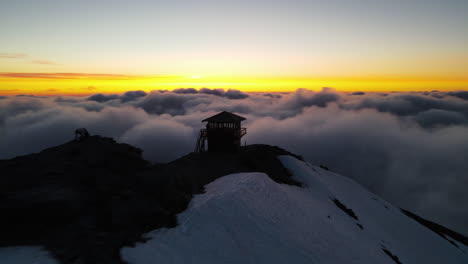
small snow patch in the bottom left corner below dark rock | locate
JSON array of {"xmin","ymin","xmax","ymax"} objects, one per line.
[{"xmin": 0, "ymin": 246, "xmax": 58, "ymax": 264}]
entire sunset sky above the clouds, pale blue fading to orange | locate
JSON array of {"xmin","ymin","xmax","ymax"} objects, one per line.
[{"xmin": 0, "ymin": 0, "xmax": 468, "ymax": 95}]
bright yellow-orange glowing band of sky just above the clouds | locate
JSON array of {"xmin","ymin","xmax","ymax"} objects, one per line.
[{"xmin": 0, "ymin": 73, "xmax": 468, "ymax": 95}]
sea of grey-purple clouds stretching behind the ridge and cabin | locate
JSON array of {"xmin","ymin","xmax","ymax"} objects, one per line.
[{"xmin": 0, "ymin": 88, "xmax": 468, "ymax": 234}]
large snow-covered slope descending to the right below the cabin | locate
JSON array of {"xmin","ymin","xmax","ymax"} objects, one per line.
[{"xmin": 121, "ymin": 156, "xmax": 468, "ymax": 264}]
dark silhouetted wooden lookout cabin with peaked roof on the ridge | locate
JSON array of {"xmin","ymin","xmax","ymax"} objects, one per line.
[{"xmin": 195, "ymin": 111, "xmax": 247, "ymax": 152}]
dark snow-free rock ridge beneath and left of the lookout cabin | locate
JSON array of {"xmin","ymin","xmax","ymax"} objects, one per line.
[{"xmin": 0, "ymin": 136, "xmax": 468, "ymax": 264}]
